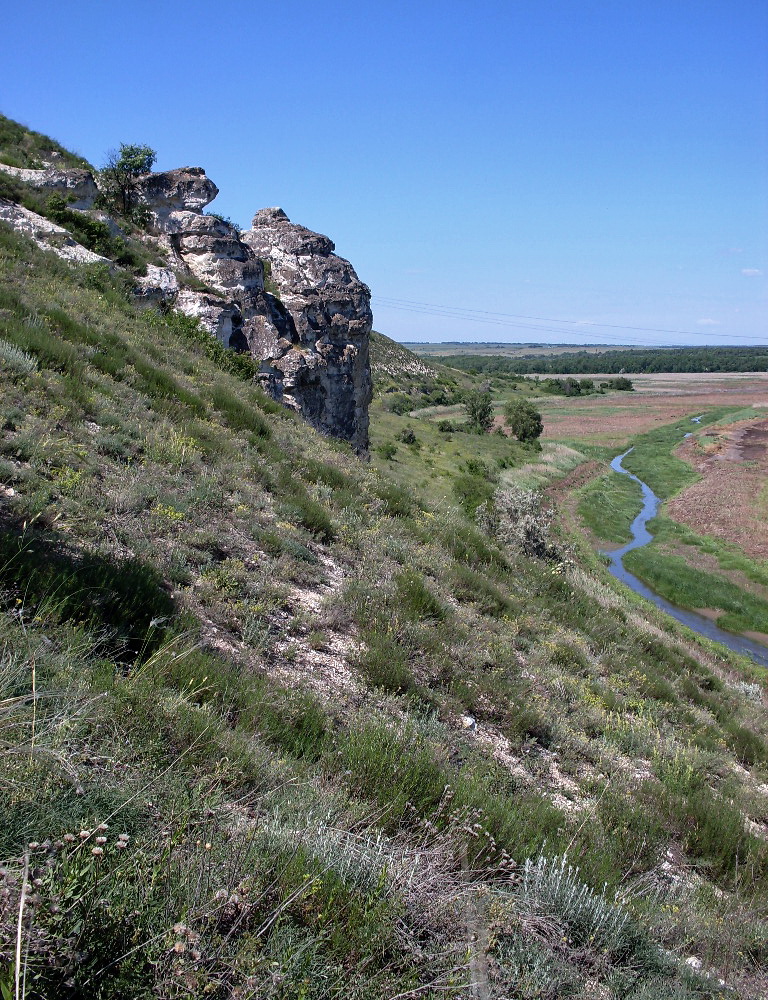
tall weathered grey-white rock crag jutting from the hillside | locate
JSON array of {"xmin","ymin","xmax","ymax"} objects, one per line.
[{"xmin": 136, "ymin": 167, "xmax": 372, "ymax": 453}]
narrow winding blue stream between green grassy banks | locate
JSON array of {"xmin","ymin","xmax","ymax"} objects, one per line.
[{"xmin": 607, "ymin": 448, "xmax": 768, "ymax": 667}]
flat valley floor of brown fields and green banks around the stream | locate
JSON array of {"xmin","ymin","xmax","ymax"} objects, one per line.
[{"xmin": 556, "ymin": 373, "xmax": 768, "ymax": 641}]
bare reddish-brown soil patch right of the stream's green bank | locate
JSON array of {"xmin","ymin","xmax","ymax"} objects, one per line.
[{"xmin": 666, "ymin": 418, "xmax": 768, "ymax": 559}]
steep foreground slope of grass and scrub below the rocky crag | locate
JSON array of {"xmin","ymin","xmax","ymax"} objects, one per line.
[{"xmin": 0, "ymin": 123, "xmax": 768, "ymax": 1000}]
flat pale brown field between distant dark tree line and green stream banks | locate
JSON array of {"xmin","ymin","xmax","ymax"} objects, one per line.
[{"xmin": 537, "ymin": 372, "xmax": 768, "ymax": 447}]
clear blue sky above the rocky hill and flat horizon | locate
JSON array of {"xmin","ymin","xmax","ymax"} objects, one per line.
[{"xmin": 0, "ymin": 0, "xmax": 768, "ymax": 343}]
